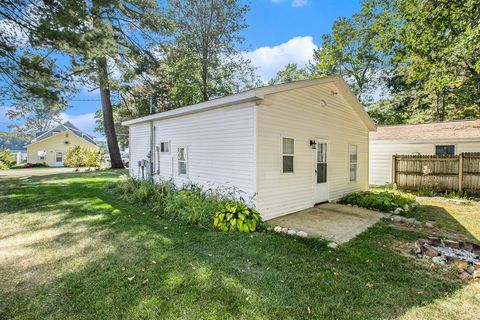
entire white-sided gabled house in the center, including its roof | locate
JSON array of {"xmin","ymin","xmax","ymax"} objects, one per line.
[{"xmin": 123, "ymin": 77, "xmax": 375, "ymax": 219}]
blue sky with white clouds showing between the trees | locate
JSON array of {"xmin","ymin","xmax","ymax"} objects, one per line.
[{"xmin": 0, "ymin": 0, "xmax": 360, "ymax": 136}]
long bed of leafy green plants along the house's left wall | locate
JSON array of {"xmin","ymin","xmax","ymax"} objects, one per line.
[{"xmin": 110, "ymin": 178, "xmax": 260, "ymax": 232}]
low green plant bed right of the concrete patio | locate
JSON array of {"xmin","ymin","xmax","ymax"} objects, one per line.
[{"xmin": 339, "ymin": 190, "xmax": 415, "ymax": 212}]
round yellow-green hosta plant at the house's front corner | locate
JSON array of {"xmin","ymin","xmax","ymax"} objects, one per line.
[{"xmin": 213, "ymin": 201, "xmax": 260, "ymax": 232}]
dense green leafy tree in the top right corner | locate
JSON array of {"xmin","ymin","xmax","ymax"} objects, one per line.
[{"xmin": 394, "ymin": 0, "xmax": 480, "ymax": 121}]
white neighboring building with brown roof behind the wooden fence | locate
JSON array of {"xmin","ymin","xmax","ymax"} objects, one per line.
[{"xmin": 369, "ymin": 120, "xmax": 480, "ymax": 185}]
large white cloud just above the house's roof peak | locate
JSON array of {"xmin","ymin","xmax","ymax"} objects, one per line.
[{"xmin": 245, "ymin": 36, "xmax": 318, "ymax": 81}]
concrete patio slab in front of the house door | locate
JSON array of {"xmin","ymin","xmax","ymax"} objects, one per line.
[{"xmin": 267, "ymin": 203, "xmax": 384, "ymax": 244}]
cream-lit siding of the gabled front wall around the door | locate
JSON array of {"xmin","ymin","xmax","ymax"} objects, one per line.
[{"xmin": 257, "ymin": 84, "xmax": 368, "ymax": 219}]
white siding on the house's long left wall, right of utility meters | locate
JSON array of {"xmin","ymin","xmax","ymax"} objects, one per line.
[{"xmin": 150, "ymin": 104, "xmax": 256, "ymax": 198}]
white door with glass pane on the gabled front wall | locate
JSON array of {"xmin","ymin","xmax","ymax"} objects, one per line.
[{"xmin": 313, "ymin": 139, "xmax": 329, "ymax": 203}]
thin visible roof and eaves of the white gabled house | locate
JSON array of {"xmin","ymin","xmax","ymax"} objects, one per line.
[{"xmin": 122, "ymin": 76, "xmax": 376, "ymax": 131}]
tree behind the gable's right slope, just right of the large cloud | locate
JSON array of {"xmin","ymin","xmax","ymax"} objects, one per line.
[{"xmin": 310, "ymin": 3, "xmax": 387, "ymax": 104}]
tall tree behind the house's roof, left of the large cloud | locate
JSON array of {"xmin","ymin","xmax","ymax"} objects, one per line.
[{"xmin": 166, "ymin": 0, "xmax": 255, "ymax": 106}]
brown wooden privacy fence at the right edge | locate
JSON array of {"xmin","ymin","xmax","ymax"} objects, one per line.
[{"xmin": 392, "ymin": 152, "xmax": 480, "ymax": 194}]
